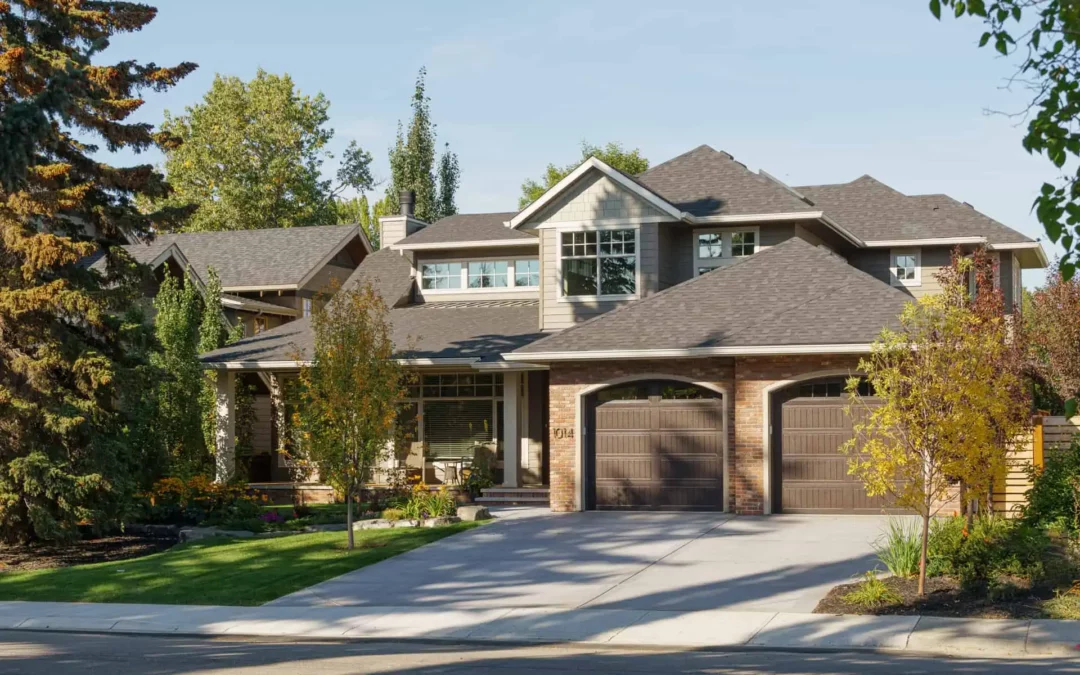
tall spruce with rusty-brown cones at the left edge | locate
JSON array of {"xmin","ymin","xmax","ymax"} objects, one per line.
[{"xmin": 0, "ymin": 0, "xmax": 195, "ymax": 540}]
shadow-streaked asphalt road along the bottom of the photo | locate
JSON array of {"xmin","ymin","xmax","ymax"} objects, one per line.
[{"xmin": 0, "ymin": 631, "xmax": 1080, "ymax": 675}]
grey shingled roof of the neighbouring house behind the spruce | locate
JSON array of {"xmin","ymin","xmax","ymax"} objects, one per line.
[{"xmin": 91, "ymin": 225, "xmax": 367, "ymax": 291}]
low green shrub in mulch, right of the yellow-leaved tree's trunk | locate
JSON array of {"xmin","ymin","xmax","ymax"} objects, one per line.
[{"xmin": 928, "ymin": 515, "xmax": 1051, "ymax": 589}]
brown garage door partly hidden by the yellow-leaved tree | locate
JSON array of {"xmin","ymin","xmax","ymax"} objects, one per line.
[{"xmin": 779, "ymin": 397, "xmax": 889, "ymax": 513}]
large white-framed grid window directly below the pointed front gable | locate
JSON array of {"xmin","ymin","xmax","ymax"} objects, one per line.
[{"xmin": 561, "ymin": 229, "xmax": 637, "ymax": 297}]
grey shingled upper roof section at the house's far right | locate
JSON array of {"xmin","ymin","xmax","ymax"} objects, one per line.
[{"xmin": 795, "ymin": 175, "xmax": 1034, "ymax": 244}]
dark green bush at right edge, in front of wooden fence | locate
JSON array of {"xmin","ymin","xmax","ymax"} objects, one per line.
[{"xmin": 1022, "ymin": 437, "xmax": 1080, "ymax": 537}]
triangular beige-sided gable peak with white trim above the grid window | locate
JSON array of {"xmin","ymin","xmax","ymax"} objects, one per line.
[{"xmin": 525, "ymin": 171, "xmax": 666, "ymax": 227}]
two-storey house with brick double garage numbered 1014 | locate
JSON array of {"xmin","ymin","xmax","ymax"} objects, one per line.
[{"xmin": 205, "ymin": 146, "xmax": 1047, "ymax": 514}]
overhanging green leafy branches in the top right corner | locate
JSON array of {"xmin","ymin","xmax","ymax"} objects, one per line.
[{"xmin": 930, "ymin": 0, "xmax": 1080, "ymax": 281}]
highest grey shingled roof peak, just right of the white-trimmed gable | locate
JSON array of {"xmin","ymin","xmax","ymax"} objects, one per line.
[{"xmin": 636, "ymin": 145, "xmax": 816, "ymax": 217}]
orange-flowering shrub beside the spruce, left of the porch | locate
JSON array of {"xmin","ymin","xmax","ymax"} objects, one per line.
[{"xmin": 143, "ymin": 476, "xmax": 267, "ymax": 525}]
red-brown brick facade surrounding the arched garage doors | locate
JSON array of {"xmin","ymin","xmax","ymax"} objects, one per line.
[{"xmin": 548, "ymin": 355, "xmax": 859, "ymax": 514}]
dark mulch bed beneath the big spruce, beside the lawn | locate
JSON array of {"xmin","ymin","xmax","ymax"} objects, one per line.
[{"xmin": 0, "ymin": 536, "xmax": 176, "ymax": 571}]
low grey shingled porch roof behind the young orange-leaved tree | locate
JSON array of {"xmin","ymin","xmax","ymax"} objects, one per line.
[{"xmin": 201, "ymin": 300, "xmax": 543, "ymax": 368}]
